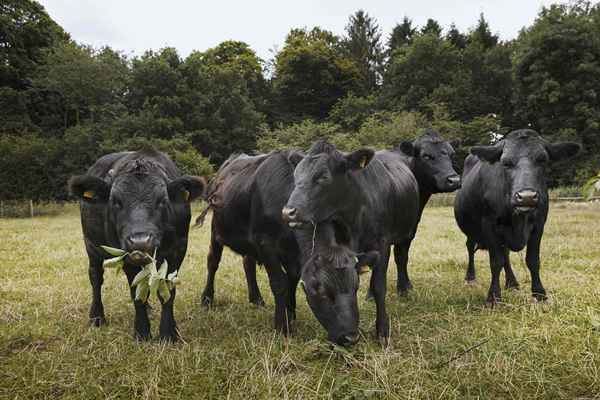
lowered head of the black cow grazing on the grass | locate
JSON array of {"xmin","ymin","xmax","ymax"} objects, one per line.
[{"xmin": 301, "ymin": 245, "xmax": 379, "ymax": 346}]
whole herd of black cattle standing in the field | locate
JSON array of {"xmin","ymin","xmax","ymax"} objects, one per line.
[{"xmin": 69, "ymin": 130, "xmax": 580, "ymax": 345}]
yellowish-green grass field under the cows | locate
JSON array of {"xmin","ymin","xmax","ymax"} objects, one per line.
[{"xmin": 0, "ymin": 203, "xmax": 600, "ymax": 399}]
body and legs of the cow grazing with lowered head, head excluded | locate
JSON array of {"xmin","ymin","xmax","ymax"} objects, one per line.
[{"xmin": 202, "ymin": 150, "xmax": 302, "ymax": 334}]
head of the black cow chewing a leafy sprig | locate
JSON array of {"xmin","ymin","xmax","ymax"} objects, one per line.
[{"xmin": 69, "ymin": 157, "xmax": 205, "ymax": 264}]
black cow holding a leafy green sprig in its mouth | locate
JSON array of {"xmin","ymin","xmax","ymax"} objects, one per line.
[{"xmin": 69, "ymin": 150, "xmax": 205, "ymax": 341}]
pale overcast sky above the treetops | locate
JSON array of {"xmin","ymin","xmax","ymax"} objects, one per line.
[{"xmin": 41, "ymin": 0, "xmax": 557, "ymax": 59}]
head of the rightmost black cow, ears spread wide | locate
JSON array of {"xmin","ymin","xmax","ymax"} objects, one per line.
[{"xmin": 471, "ymin": 129, "xmax": 581, "ymax": 213}]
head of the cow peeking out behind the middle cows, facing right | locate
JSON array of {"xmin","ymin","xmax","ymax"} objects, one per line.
[{"xmin": 400, "ymin": 129, "xmax": 460, "ymax": 193}]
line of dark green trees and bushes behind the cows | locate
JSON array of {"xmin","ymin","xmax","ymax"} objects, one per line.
[{"xmin": 0, "ymin": 0, "xmax": 600, "ymax": 200}]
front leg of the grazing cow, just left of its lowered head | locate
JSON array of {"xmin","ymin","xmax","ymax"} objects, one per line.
[{"xmin": 265, "ymin": 257, "xmax": 292, "ymax": 335}]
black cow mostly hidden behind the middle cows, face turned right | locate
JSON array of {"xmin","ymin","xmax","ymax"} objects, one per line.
[{"xmin": 394, "ymin": 129, "xmax": 460, "ymax": 295}]
